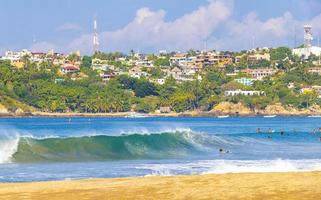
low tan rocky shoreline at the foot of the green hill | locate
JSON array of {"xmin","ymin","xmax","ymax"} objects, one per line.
[{"xmin": 0, "ymin": 102, "xmax": 321, "ymax": 117}]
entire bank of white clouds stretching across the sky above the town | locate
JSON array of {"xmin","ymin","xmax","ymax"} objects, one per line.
[{"xmin": 26, "ymin": 0, "xmax": 321, "ymax": 53}]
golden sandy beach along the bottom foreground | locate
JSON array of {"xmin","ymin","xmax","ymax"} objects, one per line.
[{"xmin": 0, "ymin": 172, "xmax": 321, "ymax": 200}]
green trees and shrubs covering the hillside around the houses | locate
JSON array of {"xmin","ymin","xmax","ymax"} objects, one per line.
[{"xmin": 0, "ymin": 47, "xmax": 321, "ymax": 113}]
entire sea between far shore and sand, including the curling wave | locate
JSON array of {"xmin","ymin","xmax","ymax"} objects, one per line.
[{"xmin": 0, "ymin": 117, "xmax": 321, "ymax": 182}]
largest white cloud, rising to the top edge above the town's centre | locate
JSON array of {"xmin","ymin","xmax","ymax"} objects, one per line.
[{"xmin": 65, "ymin": 0, "xmax": 233, "ymax": 52}]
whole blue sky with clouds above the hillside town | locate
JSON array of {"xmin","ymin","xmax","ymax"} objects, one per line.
[{"xmin": 0, "ymin": 0, "xmax": 321, "ymax": 54}]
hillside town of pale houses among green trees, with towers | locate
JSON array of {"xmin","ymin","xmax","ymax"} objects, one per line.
[{"xmin": 0, "ymin": 26, "xmax": 321, "ymax": 115}]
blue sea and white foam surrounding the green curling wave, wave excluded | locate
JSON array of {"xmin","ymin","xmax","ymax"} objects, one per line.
[{"xmin": 0, "ymin": 117, "xmax": 321, "ymax": 182}]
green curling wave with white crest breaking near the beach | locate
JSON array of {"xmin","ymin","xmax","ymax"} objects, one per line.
[{"xmin": 0, "ymin": 131, "xmax": 218, "ymax": 163}]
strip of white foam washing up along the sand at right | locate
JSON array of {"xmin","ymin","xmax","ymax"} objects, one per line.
[{"xmin": 136, "ymin": 159, "xmax": 321, "ymax": 176}]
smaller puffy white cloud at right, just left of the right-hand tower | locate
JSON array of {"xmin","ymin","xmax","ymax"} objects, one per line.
[{"xmin": 216, "ymin": 12, "xmax": 294, "ymax": 49}]
